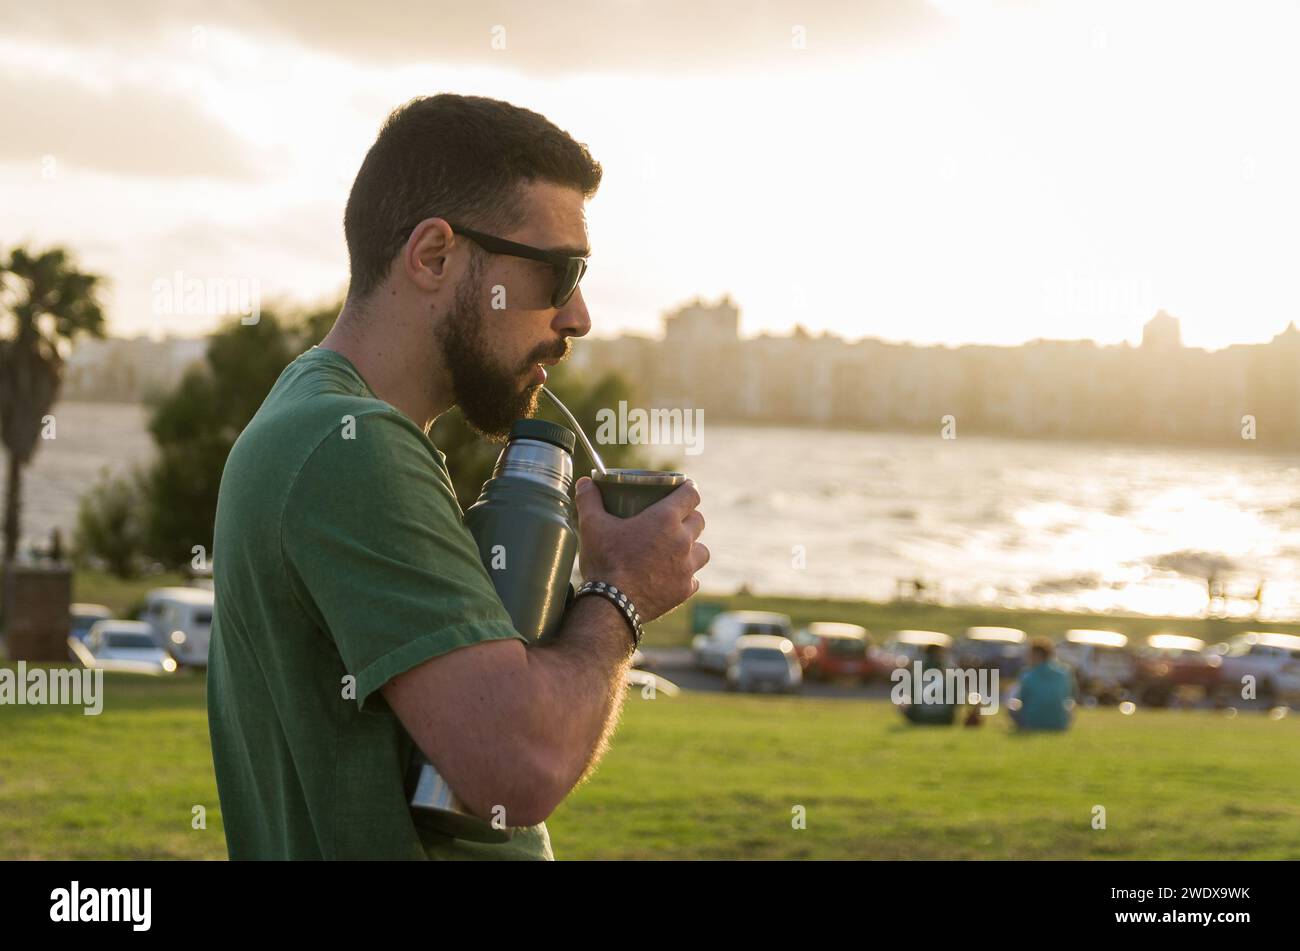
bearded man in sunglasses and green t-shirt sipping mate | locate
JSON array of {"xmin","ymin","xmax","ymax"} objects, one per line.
[{"xmin": 208, "ymin": 95, "xmax": 709, "ymax": 859}]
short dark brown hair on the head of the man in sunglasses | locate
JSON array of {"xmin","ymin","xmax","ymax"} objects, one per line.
[{"xmin": 343, "ymin": 94, "xmax": 601, "ymax": 300}]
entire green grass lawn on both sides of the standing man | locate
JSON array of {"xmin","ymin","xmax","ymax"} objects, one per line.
[{"xmin": 0, "ymin": 674, "xmax": 1300, "ymax": 859}]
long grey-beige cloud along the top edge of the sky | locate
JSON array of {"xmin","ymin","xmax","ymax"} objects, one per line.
[{"xmin": 5, "ymin": 0, "xmax": 949, "ymax": 75}]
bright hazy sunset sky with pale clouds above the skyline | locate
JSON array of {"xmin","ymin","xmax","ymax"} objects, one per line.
[{"xmin": 0, "ymin": 0, "xmax": 1300, "ymax": 348}]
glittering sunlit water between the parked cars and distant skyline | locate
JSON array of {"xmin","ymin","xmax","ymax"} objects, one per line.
[{"xmin": 12, "ymin": 403, "xmax": 1300, "ymax": 620}]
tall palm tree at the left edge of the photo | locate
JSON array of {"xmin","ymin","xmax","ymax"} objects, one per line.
[{"xmin": 0, "ymin": 248, "xmax": 104, "ymax": 564}]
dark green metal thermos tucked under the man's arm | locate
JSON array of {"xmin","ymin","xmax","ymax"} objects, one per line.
[{"xmin": 411, "ymin": 420, "xmax": 577, "ymax": 842}]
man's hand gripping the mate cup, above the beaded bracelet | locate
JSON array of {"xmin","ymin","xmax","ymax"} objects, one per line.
[{"xmin": 575, "ymin": 476, "xmax": 709, "ymax": 622}]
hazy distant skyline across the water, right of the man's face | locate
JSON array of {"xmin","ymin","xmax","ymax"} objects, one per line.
[{"xmin": 585, "ymin": 298, "xmax": 1300, "ymax": 448}]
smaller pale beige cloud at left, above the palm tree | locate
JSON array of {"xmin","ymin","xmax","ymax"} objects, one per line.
[{"xmin": 0, "ymin": 73, "xmax": 266, "ymax": 182}]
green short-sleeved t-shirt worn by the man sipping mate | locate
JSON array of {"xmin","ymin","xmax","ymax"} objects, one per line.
[{"xmin": 208, "ymin": 348, "xmax": 553, "ymax": 859}]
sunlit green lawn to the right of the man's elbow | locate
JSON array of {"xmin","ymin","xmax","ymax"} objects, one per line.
[{"xmin": 550, "ymin": 694, "xmax": 1300, "ymax": 859}]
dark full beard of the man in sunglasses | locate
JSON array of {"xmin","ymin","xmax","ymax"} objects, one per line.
[{"xmin": 441, "ymin": 257, "xmax": 559, "ymax": 442}]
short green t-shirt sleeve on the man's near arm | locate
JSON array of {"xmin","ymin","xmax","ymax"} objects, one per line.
[{"xmin": 281, "ymin": 412, "xmax": 527, "ymax": 711}]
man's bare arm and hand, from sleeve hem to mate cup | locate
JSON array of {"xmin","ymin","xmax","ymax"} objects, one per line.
[{"xmin": 384, "ymin": 478, "xmax": 709, "ymax": 825}]
